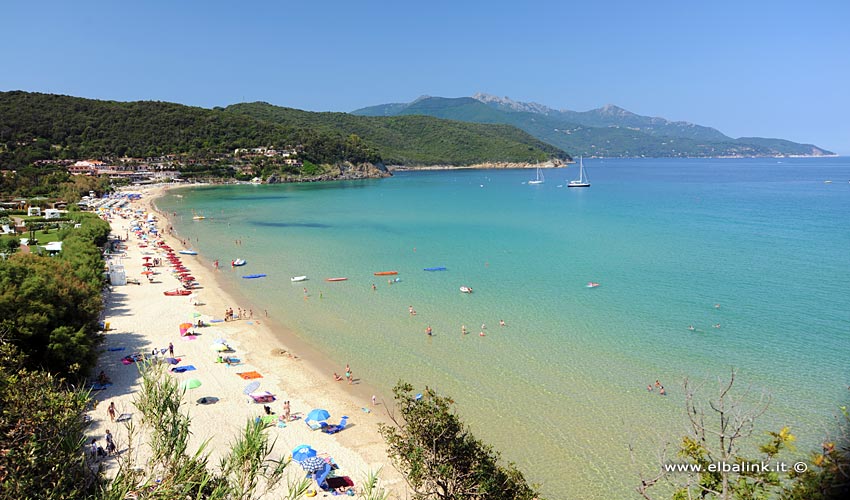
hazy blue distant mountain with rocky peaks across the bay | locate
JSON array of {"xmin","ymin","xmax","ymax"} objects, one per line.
[{"xmin": 352, "ymin": 93, "xmax": 833, "ymax": 157}]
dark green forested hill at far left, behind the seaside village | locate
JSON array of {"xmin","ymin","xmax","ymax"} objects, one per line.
[{"xmin": 0, "ymin": 91, "xmax": 380, "ymax": 168}]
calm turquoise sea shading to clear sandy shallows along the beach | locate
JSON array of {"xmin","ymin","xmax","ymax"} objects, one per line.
[{"xmin": 157, "ymin": 158, "xmax": 850, "ymax": 499}]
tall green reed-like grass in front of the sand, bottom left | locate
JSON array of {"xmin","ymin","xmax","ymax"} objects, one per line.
[{"xmin": 101, "ymin": 363, "xmax": 298, "ymax": 500}]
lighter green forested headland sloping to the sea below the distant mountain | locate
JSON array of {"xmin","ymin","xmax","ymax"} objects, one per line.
[{"xmin": 226, "ymin": 102, "xmax": 570, "ymax": 166}]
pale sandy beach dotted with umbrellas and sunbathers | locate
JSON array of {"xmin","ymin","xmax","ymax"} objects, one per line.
[{"xmin": 88, "ymin": 186, "xmax": 408, "ymax": 498}]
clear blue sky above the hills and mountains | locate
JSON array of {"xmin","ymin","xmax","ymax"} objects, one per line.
[{"xmin": 0, "ymin": 0, "xmax": 850, "ymax": 154}]
